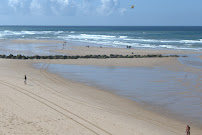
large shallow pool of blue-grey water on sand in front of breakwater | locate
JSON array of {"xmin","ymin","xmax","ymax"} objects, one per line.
[{"xmin": 34, "ymin": 64, "xmax": 202, "ymax": 124}]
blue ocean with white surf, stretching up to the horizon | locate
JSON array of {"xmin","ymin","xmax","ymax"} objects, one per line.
[{"xmin": 0, "ymin": 26, "xmax": 202, "ymax": 51}]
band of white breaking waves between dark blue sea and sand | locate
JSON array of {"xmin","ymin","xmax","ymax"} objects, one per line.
[{"xmin": 0, "ymin": 30, "xmax": 202, "ymax": 50}]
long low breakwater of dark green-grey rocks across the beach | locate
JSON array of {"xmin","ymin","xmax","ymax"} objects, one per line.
[{"xmin": 0, "ymin": 54, "xmax": 187, "ymax": 59}]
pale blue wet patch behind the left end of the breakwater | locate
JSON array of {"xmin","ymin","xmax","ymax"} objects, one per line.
[{"xmin": 0, "ymin": 40, "xmax": 64, "ymax": 55}]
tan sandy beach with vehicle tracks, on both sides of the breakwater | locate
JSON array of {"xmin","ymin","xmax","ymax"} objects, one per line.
[{"xmin": 0, "ymin": 41, "xmax": 202, "ymax": 135}]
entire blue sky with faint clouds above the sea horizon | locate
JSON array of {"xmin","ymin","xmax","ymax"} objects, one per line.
[{"xmin": 0, "ymin": 0, "xmax": 202, "ymax": 26}]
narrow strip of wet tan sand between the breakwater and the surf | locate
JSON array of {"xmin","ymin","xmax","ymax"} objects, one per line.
[{"xmin": 0, "ymin": 39, "xmax": 202, "ymax": 56}]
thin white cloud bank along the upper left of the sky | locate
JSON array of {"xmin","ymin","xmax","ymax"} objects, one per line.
[{"xmin": 0, "ymin": 0, "xmax": 126, "ymax": 16}]
